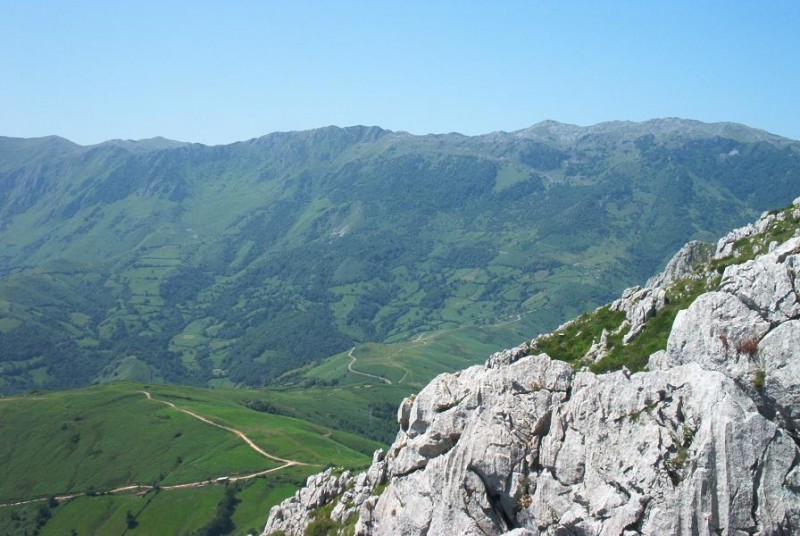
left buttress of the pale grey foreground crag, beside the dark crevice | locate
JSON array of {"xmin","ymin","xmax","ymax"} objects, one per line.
[{"xmin": 356, "ymin": 356, "xmax": 572, "ymax": 534}]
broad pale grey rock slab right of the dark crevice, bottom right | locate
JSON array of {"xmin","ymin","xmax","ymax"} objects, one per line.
[{"xmin": 525, "ymin": 364, "xmax": 800, "ymax": 534}]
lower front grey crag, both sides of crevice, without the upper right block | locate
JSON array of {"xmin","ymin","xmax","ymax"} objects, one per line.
[{"xmin": 356, "ymin": 356, "xmax": 800, "ymax": 535}]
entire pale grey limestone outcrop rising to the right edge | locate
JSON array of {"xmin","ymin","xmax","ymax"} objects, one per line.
[{"xmin": 266, "ymin": 200, "xmax": 800, "ymax": 536}]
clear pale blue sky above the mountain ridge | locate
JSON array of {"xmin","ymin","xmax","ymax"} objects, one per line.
[{"xmin": 0, "ymin": 0, "xmax": 800, "ymax": 144}]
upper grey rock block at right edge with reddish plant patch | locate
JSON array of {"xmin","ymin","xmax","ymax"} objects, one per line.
[{"xmin": 649, "ymin": 238, "xmax": 800, "ymax": 416}]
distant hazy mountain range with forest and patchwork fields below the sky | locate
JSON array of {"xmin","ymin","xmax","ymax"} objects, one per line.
[{"xmin": 0, "ymin": 119, "xmax": 800, "ymax": 395}]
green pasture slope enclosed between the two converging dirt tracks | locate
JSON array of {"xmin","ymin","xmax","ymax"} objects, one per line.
[{"xmin": 0, "ymin": 384, "xmax": 268, "ymax": 501}]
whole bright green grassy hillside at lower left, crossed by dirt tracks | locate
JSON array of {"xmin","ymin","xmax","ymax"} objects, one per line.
[{"xmin": 0, "ymin": 383, "xmax": 379, "ymax": 534}]
